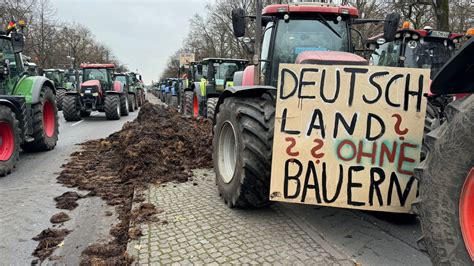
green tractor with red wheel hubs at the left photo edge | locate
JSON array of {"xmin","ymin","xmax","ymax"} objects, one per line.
[{"xmin": 0, "ymin": 22, "xmax": 59, "ymax": 176}]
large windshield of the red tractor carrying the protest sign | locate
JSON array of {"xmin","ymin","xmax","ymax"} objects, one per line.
[{"xmin": 271, "ymin": 17, "xmax": 350, "ymax": 86}]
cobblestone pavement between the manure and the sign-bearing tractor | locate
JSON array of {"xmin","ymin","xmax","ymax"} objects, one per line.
[{"xmin": 128, "ymin": 170, "xmax": 352, "ymax": 265}]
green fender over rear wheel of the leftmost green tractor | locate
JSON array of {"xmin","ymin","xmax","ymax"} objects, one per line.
[{"xmin": 14, "ymin": 76, "xmax": 56, "ymax": 104}]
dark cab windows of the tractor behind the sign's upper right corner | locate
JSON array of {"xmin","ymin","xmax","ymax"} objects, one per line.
[{"xmin": 405, "ymin": 38, "xmax": 454, "ymax": 76}]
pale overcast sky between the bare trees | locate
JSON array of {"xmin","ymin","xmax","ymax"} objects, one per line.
[{"xmin": 51, "ymin": 0, "xmax": 213, "ymax": 84}]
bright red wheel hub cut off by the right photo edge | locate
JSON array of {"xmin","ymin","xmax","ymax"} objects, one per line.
[{"xmin": 459, "ymin": 168, "xmax": 474, "ymax": 261}]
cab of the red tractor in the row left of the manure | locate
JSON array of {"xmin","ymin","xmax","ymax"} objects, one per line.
[{"xmin": 81, "ymin": 64, "xmax": 115, "ymax": 94}]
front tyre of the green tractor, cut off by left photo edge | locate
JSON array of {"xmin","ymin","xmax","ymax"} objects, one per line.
[{"xmin": 0, "ymin": 105, "xmax": 21, "ymax": 176}]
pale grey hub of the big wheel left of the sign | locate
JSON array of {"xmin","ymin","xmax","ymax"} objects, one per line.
[{"xmin": 218, "ymin": 122, "xmax": 237, "ymax": 184}]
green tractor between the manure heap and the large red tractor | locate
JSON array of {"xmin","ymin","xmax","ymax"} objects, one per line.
[{"xmin": 183, "ymin": 58, "xmax": 249, "ymax": 118}]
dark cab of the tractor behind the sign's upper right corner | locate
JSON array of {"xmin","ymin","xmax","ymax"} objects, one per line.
[{"xmin": 367, "ymin": 25, "xmax": 464, "ymax": 77}]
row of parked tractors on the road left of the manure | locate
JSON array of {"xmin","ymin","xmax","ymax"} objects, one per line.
[{"xmin": 0, "ymin": 20, "xmax": 145, "ymax": 177}]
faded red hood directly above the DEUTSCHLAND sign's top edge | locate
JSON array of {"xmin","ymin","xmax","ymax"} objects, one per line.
[{"xmin": 295, "ymin": 51, "xmax": 369, "ymax": 65}]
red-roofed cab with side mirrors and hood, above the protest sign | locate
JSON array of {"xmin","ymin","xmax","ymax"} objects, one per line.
[{"xmin": 232, "ymin": 2, "xmax": 400, "ymax": 87}]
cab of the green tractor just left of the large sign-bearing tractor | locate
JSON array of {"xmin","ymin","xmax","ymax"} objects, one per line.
[{"xmin": 201, "ymin": 58, "xmax": 249, "ymax": 97}]
